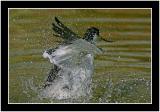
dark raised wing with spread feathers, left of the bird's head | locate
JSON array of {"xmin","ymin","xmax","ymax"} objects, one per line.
[{"xmin": 52, "ymin": 17, "xmax": 80, "ymax": 41}]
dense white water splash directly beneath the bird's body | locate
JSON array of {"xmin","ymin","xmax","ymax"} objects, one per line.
[{"xmin": 41, "ymin": 55, "xmax": 93, "ymax": 100}]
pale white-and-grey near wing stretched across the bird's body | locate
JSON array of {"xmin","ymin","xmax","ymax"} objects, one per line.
[{"xmin": 43, "ymin": 39, "xmax": 101, "ymax": 68}]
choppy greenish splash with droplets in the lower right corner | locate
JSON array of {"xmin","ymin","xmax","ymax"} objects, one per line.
[{"xmin": 97, "ymin": 78, "xmax": 151, "ymax": 103}]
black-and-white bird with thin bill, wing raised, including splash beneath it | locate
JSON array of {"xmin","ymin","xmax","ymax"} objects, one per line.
[{"xmin": 43, "ymin": 17, "xmax": 113, "ymax": 99}]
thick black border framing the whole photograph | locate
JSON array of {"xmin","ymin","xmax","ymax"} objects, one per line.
[{"xmin": 1, "ymin": 1, "xmax": 159, "ymax": 111}]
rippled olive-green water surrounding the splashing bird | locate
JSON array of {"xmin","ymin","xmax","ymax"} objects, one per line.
[{"xmin": 9, "ymin": 9, "xmax": 151, "ymax": 103}]
